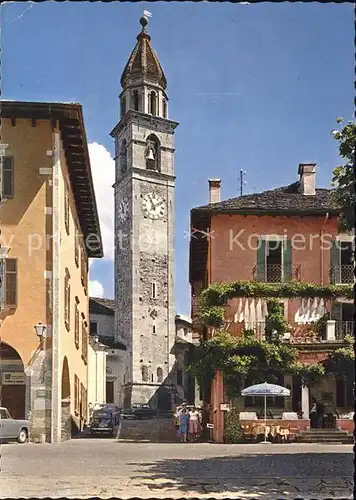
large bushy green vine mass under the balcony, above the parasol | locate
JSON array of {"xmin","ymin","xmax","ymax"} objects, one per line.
[{"xmin": 190, "ymin": 332, "xmax": 297, "ymax": 397}]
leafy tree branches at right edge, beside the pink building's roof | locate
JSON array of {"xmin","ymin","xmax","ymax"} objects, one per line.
[{"xmin": 332, "ymin": 118, "xmax": 356, "ymax": 232}]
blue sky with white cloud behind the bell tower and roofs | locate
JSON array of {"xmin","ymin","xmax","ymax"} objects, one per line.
[{"xmin": 1, "ymin": 2, "xmax": 354, "ymax": 314}]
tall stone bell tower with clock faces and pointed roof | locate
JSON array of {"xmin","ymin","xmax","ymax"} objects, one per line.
[{"xmin": 111, "ymin": 16, "xmax": 178, "ymax": 409}]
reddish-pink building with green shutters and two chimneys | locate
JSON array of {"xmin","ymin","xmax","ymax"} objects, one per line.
[{"xmin": 190, "ymin": 164, "xmax": 354, "ymax": 438}]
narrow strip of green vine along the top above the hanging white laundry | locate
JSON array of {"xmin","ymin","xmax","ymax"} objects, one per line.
[{"xmin": 200, "ymin": 281, "xmax": 353, "ymax": 333}]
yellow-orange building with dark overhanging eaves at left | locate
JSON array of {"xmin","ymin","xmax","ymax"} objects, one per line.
[{"xmin": 0, "ymin": 101, "xmax": 102, "ymax": 442}]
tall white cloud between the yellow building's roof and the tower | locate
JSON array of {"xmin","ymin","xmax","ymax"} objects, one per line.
[{"xmin": 88, "ymin": 142, "xmax": 115, "ymax": 267}]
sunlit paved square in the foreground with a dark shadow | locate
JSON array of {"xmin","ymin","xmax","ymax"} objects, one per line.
[{"xmin": 0, "ymin": 439, "xmax": 353, "ymax": 500}]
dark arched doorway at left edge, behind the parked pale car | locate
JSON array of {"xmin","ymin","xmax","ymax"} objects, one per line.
[{"xmin": 0, "ymin": 342, "xmax": 26, "ymax": 419}]
